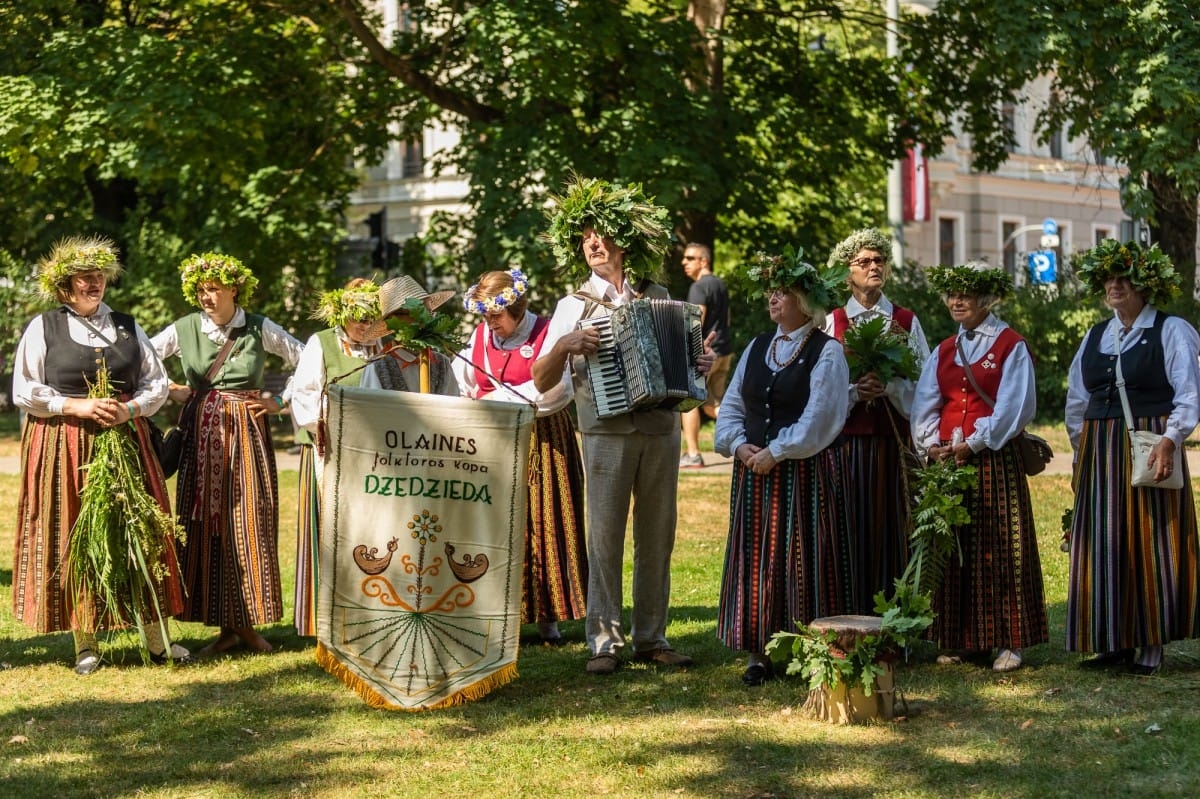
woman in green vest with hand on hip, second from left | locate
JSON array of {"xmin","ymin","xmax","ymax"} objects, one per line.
[{"xmin": 152, "ymin": 252, "xmax": 301, "ymax": 656}]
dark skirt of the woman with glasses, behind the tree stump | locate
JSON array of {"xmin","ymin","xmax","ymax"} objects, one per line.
[{"xmin": 820, "ymin": 420, "xmax": 912, "ymax": 614}]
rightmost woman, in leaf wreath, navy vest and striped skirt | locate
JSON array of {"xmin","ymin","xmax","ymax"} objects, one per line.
[{"xmin": 1066, "ymin": 239, "xmax": 1200, "ymax": 675}]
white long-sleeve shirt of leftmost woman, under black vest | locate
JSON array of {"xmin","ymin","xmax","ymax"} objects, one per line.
[{"xmin": 12, "ymin": 302, "xmax": 169, "ymax": 417}]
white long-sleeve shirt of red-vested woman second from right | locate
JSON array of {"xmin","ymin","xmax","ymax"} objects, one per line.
[{"xmin": 911, "ymin": 313, "xmax": 1038, "ymax": 452}]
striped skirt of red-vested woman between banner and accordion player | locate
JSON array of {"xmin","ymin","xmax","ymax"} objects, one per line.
[{"xmin": 521, "ymin": 409, "xmax": 588, "ymax": 624}]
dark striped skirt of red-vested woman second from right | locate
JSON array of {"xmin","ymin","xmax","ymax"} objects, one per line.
[{"xmin": 930, "ymin": 441, "xmax": 1049, "ymax": 651}]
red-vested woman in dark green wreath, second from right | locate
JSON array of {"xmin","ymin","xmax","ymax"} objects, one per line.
[{"xmin": 912, "ymin": 262, "xmax": 1049, "ymax": 672}]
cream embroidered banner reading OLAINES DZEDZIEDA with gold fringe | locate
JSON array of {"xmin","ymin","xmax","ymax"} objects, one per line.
[{"xmin": 317, "ymin": 385, "xmax": 534, "ymax": 710}]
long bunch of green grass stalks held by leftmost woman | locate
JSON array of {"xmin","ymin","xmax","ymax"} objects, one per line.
[{"xmin": 65, "ymin": 365, "xmax": 184, "ymax": 660}]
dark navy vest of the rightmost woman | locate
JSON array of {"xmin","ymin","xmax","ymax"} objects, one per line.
[{"xmin": 1080, "ymin": 305, "xmax": 1175, "ymax": 419}]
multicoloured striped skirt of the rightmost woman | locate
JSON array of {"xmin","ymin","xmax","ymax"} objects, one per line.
[{"xmin": 1067, "ymin": 416, "xmax": 1200, "ymax": 653}]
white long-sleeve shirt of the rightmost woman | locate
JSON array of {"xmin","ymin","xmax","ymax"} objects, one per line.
[{"xmin": 1066, "ymin": 305, "xmax": 1200, "ymax": 453}]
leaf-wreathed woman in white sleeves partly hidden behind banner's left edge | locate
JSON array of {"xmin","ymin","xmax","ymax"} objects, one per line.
[{"xmin": 290, "ymin": 277, "xmax": 391, "ymax": 636}]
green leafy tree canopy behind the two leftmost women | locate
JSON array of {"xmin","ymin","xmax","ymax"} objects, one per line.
[{"xmin": 0, "ymin": 0, "xmax": 396, "ymax": 338}]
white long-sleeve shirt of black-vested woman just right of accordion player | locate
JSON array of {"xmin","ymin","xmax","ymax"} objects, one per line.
[{"xmin": 713, "ymin": 323, "xmax": 850, "ymax": 461}]
